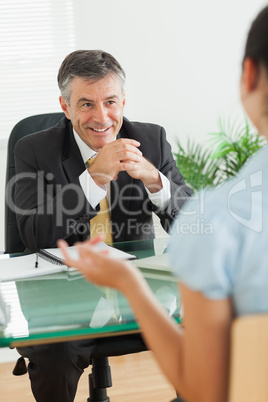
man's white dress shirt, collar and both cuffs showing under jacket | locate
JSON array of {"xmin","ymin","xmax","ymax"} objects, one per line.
[{"xmin": 73, "ymin": 130, "xmax": 171, "ymax": 210}]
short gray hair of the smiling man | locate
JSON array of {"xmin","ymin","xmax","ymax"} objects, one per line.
[{"xmin": 58, "ymin": 50, "xmax": 126, "ymax": 105}]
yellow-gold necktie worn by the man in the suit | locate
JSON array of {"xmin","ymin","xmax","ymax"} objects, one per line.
[{"xmin": 87, "ymin": 158, "xmax": 113, "ymax": 243}]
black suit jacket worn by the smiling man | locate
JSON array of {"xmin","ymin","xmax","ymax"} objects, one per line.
[{"xmin": 15, "ymin": 118, "xmax": 191, "ymax": 251}]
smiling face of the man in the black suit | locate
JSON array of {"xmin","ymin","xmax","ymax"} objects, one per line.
[{"xmin": 60, "ymin": 76, "xmax": 125, "ymax": 151}]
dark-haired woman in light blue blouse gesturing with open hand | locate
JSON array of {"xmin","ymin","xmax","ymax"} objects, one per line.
[{"xmin": 58, "ymin": 7, "xmax": 268, "ymax": 402}]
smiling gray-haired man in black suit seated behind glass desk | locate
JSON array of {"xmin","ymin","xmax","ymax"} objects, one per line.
[{"xmin": 15, "ymin": 50, "xmax": 191, "ymax": 402}]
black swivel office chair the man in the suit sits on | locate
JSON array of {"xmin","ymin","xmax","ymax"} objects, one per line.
[{"xmin": 5, "ymin": 113, "xmax": 147, "ymax": 402}]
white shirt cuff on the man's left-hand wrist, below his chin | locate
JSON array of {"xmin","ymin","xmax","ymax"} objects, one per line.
[{"xmin": 79, "ymin": 169, "xmax": 107, "ymax": 209}]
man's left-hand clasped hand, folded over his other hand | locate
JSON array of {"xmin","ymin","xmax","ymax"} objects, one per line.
[{"xmin": 88, "ymin": 138, "xmax": 142, "ymax": 186}]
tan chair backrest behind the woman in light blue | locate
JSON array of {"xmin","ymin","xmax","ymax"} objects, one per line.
[{"xmin": 228, "ymin": 314, "xmax": 268, "ymax": 402}]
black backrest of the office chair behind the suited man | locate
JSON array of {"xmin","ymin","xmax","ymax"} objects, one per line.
[{"xmin": 5, "ymin": 113, "xmax": 64, "ymax": 253}]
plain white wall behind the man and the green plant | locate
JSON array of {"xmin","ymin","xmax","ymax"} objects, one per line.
[{"xmin": 0, "ymin": 0, "xmax": 267, "ymax": 249}]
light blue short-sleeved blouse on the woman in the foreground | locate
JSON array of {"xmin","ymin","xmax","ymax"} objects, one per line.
[{"xmin": 169, "ymin": 146, "xmax": 268, "ymax": 315}]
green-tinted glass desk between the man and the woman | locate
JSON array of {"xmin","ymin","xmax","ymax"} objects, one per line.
[{"xmin": 0, "ymin": 239, "xmax": 179, "ymax": 347}]
